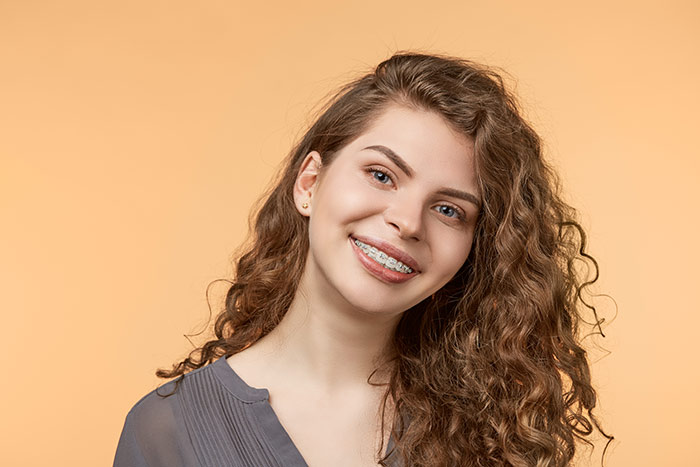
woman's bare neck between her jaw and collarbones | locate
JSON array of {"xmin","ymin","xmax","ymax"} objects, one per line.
[{"xmin": 256, "ymin": 278, "xmax": 401, "ymax": 396}]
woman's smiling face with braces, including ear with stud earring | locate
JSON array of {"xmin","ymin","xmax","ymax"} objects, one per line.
[{"xmin": 295, "ymin": 105, "xmax": 480, "ymax": 313}]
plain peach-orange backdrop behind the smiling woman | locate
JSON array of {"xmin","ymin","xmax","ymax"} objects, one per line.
[{"xmin": 0, "ymin": 0, "xmax": 700, "ymax": 466}]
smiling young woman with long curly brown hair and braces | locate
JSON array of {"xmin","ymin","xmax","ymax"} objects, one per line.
[{"xmin": 115, "ymin": 53, "xmax": 607, "ymax": 467}]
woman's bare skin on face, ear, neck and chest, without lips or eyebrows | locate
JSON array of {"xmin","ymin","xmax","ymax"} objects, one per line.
[{"xmin": 229, "ymin": 104, "xmax": 480, "ymax": 465}]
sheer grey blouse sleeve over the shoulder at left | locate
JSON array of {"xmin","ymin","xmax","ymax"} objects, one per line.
[{"xmin": 113, "ymin": 384, "xmax": 199, "ymax": 467}]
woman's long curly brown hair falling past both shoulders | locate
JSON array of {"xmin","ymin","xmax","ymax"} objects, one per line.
[{"xmin": 156, "ymin": 52, "xmax": 612, "ymax": 466}]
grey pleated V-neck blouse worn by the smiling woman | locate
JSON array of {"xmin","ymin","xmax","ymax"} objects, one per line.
[{"xmin": 114, "ymin": 357, "xmax": 396, "ymax": 467}]
